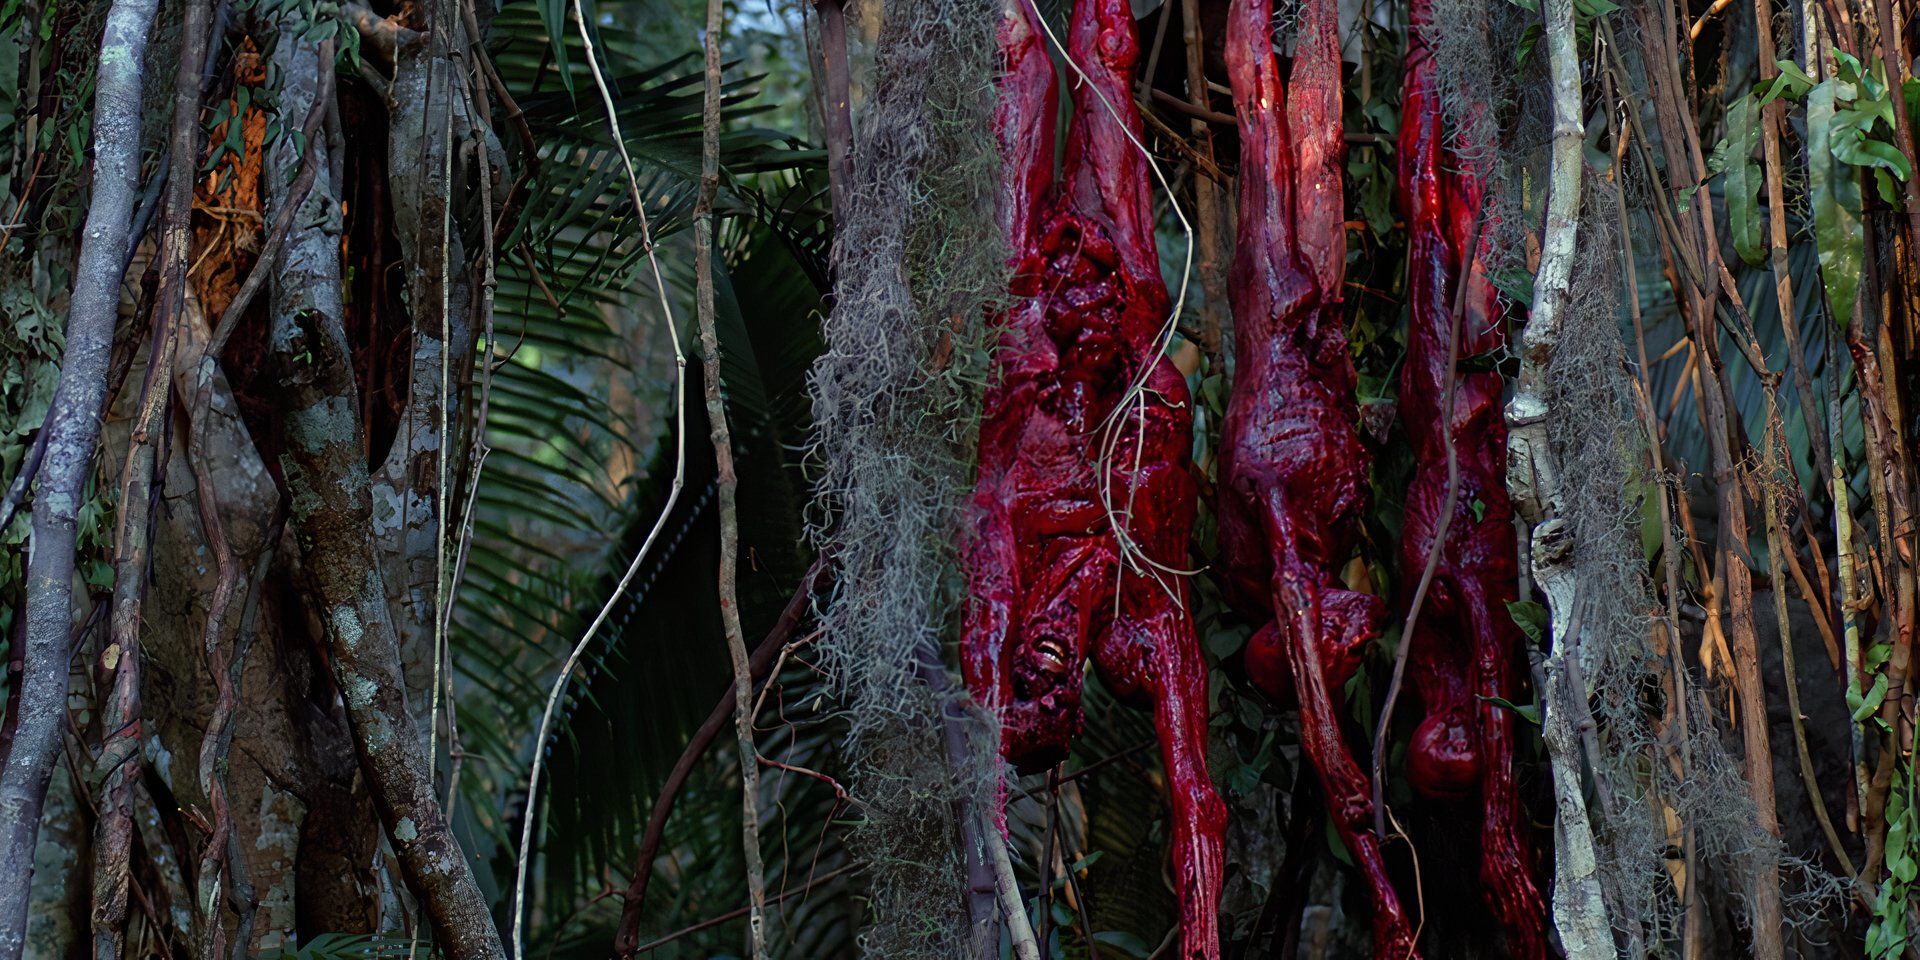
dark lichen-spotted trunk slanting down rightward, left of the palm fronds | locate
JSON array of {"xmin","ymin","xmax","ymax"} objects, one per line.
[{"xmin": 269, "ymin": 23, "xmax": 505, "ymax": 960}]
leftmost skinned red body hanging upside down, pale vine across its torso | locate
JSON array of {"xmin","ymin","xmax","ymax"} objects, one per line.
[{"xmin": 962, "ymin": 0, "xmax": 1227, "ymax": 960}]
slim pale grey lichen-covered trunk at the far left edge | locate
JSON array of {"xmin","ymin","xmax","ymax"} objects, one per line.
[{"xmin": 0, "ymin": 0, "xmax": 157, "ymax": 960}]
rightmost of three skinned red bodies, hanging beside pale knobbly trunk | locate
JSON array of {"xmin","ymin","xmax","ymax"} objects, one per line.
[{"xmin": 1400, "ymin": 0, "xmax": 1548, "ymax": 960}]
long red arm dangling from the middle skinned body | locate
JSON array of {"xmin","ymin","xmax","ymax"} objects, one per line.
[{"xmin": 1265, "ymin": 492, "xmax": 1419, "ymax": 960}]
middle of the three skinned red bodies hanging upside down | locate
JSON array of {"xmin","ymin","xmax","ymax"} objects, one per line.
[{"xmin": 1219, "ymin": 0, "xmax": 1415, "ymax": 960}]
